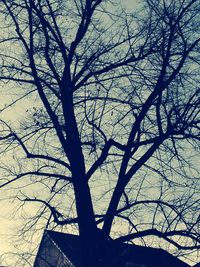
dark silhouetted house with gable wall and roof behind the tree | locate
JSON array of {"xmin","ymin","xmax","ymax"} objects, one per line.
[{"xmin": 34, "ymin": 230, "xmax": 192, "ymax": 267}]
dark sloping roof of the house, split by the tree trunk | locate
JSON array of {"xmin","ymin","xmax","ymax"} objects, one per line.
[{"xmin": 46, "ymin": 230, "xmax": 189, "ymax": 267}]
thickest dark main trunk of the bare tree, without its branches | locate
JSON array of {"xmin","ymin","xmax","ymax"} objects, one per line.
[{"xmin": 62, "ymin": 90, "xmax": 103, "ymax": 267}]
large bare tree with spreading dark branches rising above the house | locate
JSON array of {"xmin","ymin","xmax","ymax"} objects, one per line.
[{"xmin": 0, "ymin": 0, "xmax": 200, "ymax": 267}]
